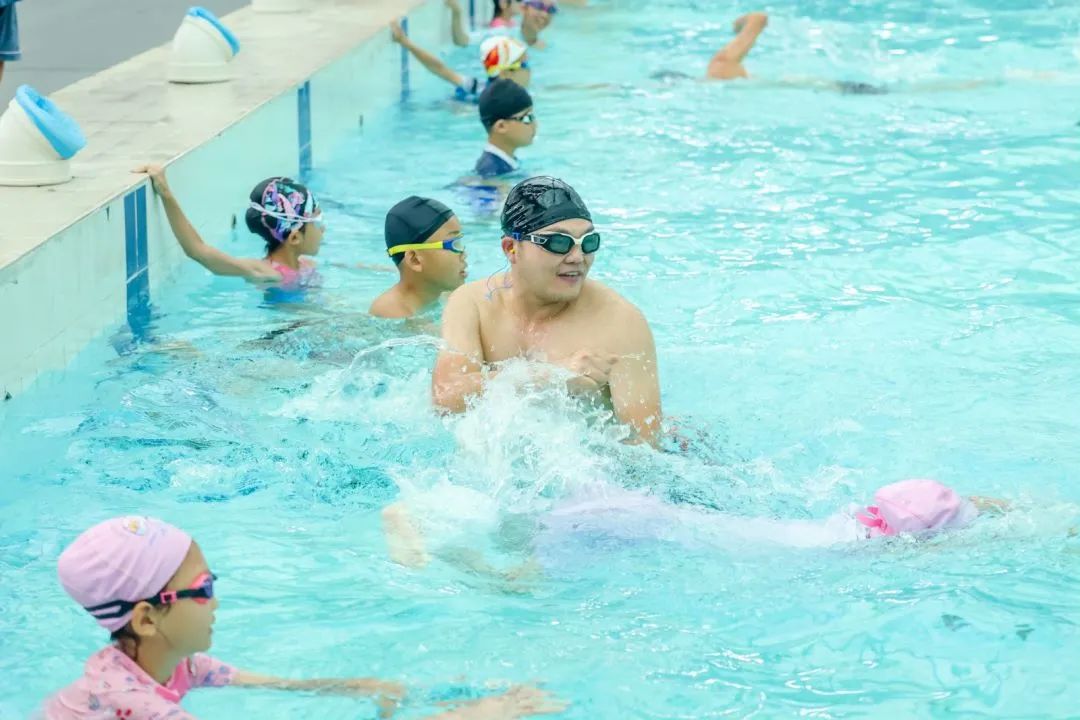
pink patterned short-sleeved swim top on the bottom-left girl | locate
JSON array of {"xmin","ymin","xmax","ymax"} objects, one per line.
[{"xmin": 44, "ymin": 646, "xmax": 235, "ymax": 720}]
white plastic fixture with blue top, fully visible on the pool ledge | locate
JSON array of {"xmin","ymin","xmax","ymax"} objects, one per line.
[{"xmin": 168, "ymin": 8, "xmax": 240, "ymax": 83}]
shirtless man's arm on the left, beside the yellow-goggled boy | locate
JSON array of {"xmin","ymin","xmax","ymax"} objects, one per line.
[{"xmin": 431, "ymin": 285, "xmax": 485, "ymax": 412}]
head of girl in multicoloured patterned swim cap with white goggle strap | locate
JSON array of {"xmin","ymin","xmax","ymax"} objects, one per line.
[{"xmin": 244, "ymin": 177, "xmax": 323, "ymax": 256}]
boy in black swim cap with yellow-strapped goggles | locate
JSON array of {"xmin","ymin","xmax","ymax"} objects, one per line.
[{"xmin": 369, "ymin": 195, "xmax": 468, "ymax": 317}]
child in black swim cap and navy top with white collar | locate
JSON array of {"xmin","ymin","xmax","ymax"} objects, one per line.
[{"xmin": 474, "ymin": 80, "xmax": 537, "ymax": 178}]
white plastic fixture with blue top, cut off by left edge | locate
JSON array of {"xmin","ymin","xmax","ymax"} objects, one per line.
[{"xmin": 0, "ymin": 85, "xmax": 86, "ymax": 185}]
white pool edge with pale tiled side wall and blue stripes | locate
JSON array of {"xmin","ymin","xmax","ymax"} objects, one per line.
[{"xmin": 0, "ymin": 0, "xmax": 468, "ymax": 402}]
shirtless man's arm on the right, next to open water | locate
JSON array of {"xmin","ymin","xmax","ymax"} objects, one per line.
[{"xmin": 608, "ymin": 307, "xmax": 663, "ymax": 445}]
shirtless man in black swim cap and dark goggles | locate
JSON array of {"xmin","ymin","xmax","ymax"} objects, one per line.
[{"xmin": 432, "ymin": 177, "xmax": 662, "ymax": 444}]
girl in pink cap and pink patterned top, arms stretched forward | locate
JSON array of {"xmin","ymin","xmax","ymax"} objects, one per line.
[{"xmin": 43, "ymin": 517, "xmax": 563, "ymax": 720}]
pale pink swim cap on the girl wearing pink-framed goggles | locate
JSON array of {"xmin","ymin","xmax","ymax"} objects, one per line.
[{"xmin": 56, "ymin": 516, "xmax": 191, "ymax": 631}]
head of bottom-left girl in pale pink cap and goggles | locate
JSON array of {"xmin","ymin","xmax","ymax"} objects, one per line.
[{"xmin": 57, "ymin": 517, "xmax": 218, "ymax": 660}]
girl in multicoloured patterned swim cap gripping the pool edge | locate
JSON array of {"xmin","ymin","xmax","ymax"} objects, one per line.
[{"xmin": 135, "ymin": 165, "xmax": 325, "ymax": 293}]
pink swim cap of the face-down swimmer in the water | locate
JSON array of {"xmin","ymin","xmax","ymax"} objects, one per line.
[{"xmin": 855, "ymin": 478, "xmax": 978, "ymax": 536}]
